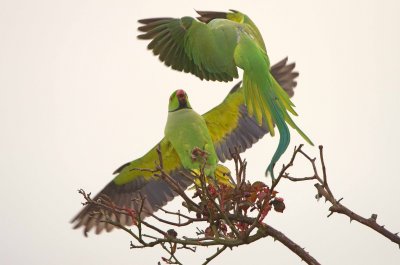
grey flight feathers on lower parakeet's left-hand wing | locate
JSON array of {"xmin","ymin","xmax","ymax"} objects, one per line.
[{"xmin": 71, "ymin": 171, "xmax": 193, "ymax": 233}]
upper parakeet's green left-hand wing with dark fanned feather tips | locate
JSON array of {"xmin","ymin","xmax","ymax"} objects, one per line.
[{"xmin": 138, "ymin": 17, "xmax": 238, "ymax": 82}]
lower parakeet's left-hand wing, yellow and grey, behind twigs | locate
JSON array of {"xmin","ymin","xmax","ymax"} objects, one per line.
[{"xmin": 71, "ymin": 139, "xmax": 192, "ymax": 235}]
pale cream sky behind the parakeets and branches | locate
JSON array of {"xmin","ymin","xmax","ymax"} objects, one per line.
[{"xmin": 0, "ymin": 0, "xmax": 400, "ymax": 265}]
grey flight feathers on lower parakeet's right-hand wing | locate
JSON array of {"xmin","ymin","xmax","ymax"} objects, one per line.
[{"xmin": 215, "ymin": 57, "xmax": 299, "ymax": 162}]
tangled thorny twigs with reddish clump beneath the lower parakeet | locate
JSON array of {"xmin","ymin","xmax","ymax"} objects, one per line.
[{"xmin": 80, "ymin": 146, "xmax": 319, "ymax": 265}]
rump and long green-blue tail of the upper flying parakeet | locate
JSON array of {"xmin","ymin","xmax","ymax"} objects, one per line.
[{"xmin": 235, "ymin": 37, "xmax": 313, "ymax": 179}]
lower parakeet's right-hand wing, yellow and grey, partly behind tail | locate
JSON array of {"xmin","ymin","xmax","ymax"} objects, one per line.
[{"xmin": 203, "ymin": 58, "xmax": 299, "ymax": 162}]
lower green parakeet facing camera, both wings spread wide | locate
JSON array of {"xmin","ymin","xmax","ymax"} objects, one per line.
[{"xmin": 71, "ymin": 58, "xmax": 298, "ymax": 234}]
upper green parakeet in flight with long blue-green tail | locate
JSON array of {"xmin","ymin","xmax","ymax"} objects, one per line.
[{"xmin": 138, "ymin": 10, "xmax": 312, "ymax": 178}]
